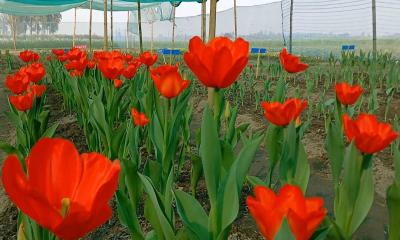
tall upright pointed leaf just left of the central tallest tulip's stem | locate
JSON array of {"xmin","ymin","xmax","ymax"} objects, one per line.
[{"xmin": 200, "ymin": 107, "xmax": 222, "ymax": 206}]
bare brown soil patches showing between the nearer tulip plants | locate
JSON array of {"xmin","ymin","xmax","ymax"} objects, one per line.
[{"xmin": 0, "ymin": 55, "xmax": 400, "ymax": 240}]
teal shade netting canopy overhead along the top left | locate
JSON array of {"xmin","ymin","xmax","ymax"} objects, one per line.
[{"xmin": 0, "ymin": 0, "xmax": 201, "ymax": 16}]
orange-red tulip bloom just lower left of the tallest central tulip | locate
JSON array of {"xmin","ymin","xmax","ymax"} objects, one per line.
[{"xmin": 150, "ymin": 65, "xmax": 190, "ymax": 98}]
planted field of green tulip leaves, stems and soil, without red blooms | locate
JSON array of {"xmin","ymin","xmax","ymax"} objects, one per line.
[{"xmin": 0, "ymin": 39, "xmax": 400, "ymax": 240}]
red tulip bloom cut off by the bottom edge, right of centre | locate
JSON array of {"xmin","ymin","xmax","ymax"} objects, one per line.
[{"xmin": 246, "ymin": 185, "xmax": 327, "ymax": 240}]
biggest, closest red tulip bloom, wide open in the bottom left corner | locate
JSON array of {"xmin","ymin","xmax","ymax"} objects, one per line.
[{"xmin": 2, "ymin": 138, "xmax": 120, "ymax": 239}]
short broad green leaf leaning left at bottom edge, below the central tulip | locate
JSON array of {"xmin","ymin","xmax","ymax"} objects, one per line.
[{"xmin": 175, "ymin": 190, "xmax": 209, "ymax": 239}]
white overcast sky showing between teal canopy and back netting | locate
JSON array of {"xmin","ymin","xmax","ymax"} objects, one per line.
[{"xmin": 62, "ymin": 0, "xmax": 277, "ymax": 22}]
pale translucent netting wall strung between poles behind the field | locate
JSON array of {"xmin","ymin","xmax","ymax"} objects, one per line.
[{"xmin": 0, "ymin": 0, "xmax": 400, "ymax": 57}]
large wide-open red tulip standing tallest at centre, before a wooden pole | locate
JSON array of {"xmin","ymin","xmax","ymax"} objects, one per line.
[{"xmin": 184, "ymin": 36, "xmax": 249, "ymax": 88}]
